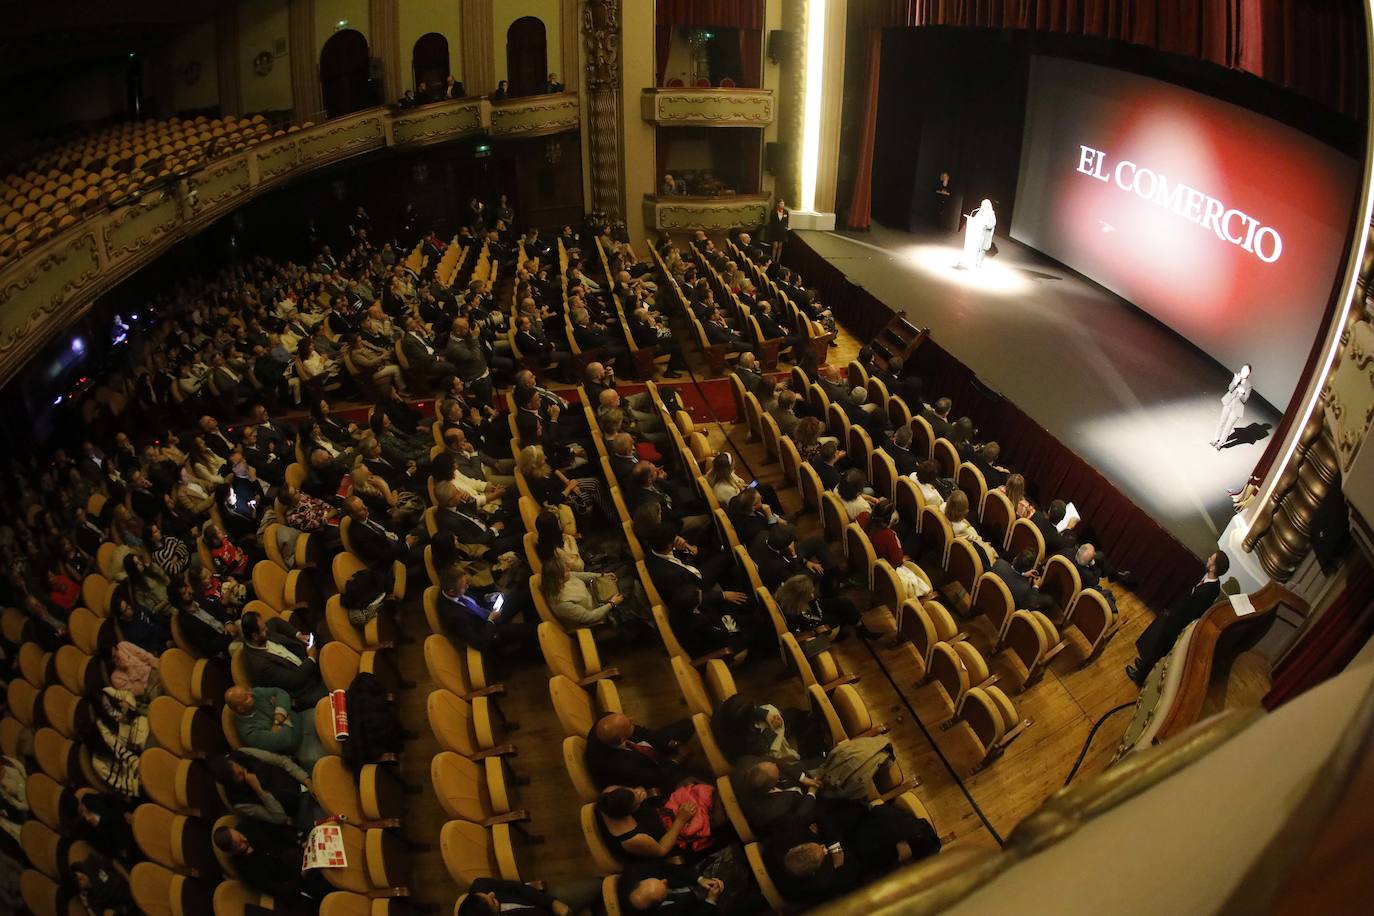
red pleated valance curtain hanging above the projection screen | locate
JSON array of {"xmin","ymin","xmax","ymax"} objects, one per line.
[{"xmin": 901, "ymin": 0, "xmax": 1366, "ymax": 115}]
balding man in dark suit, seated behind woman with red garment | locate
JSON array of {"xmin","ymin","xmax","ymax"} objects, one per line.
[{"xmin": 587, "ymin": 713, "xmax": 692, "ymax": 795}]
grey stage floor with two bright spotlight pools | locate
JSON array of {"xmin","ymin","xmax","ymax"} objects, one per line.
[{"xmin": 800, "ymin": 225, "xmax": 1281, "ymax": 556}]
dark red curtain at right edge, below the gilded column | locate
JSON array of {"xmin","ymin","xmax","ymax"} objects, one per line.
[{"xmin": 1264, "ymin": 551, "xmax": 1374, "ymax": 710}]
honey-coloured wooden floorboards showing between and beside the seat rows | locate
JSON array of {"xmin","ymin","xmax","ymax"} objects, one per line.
[{"xmin": 397, "ymin": 324, "xmax": 1151, "ymax": 912}]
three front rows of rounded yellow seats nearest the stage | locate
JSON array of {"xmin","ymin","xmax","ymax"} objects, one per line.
[{"xmin": 714, "ymin": 335, "xmax": 1121, "ymax": 768}]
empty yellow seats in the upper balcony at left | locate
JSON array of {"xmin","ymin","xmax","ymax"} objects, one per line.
[{"xmin": 0, "ymin": 114, "xmax": 287, "ymax": 264}]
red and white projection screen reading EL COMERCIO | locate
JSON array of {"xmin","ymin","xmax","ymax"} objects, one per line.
[{"xmin": 1011, "ymin": 58, "xmax": 1358, "ymax": 408}]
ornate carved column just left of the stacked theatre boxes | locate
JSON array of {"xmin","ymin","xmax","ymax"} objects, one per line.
[{"xmin": 583, "ymin": 0, "xmax": 625, "ymax": 220}]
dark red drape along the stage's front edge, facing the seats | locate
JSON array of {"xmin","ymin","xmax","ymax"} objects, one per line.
[{"xmin": 786, "ymin": 233, "xmax": 1202, "ymax": 607}]
